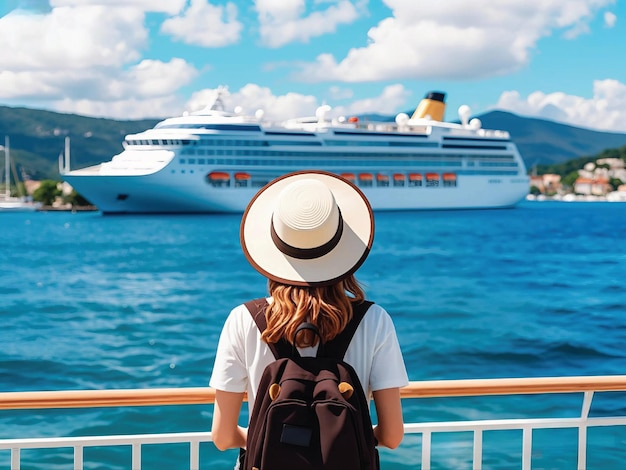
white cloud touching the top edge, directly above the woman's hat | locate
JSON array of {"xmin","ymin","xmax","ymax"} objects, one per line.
[{"xmin": 255, "ymin": 0, "xmax": 359, "ymax": 47}]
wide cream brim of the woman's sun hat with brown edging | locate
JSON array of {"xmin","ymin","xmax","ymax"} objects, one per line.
[{"xmin": 240, "ymin": 171, "xmax": 374, "ymax": 286}]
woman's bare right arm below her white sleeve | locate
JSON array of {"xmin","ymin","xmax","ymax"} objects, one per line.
[{"xmin": 372, "ymin": 388, "xmax": 404, "ymax": 449}]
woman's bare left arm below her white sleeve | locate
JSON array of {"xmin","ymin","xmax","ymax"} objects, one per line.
[{"xmin": 211, "ymin": 390, "xmax": 248, "ymax": 450}]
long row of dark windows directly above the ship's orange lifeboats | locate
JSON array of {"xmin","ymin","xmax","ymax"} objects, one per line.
[{"xmin": 178, "ymin": 156, "xmax": 518, "ymax": 168}]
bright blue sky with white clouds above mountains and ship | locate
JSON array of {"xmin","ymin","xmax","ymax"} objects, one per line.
[{"xmin": 0, "ymin": 0, "xmax": 626, "ymax": 132}]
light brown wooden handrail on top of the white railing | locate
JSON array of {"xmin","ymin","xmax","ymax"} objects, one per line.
[{"xmin": 0, "ymin": 375, "xmax": 626, "ymax": 410}]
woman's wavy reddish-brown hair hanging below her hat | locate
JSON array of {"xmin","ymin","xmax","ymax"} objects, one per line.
[{"xmin": 261, "ymin": 275, "xmax": 365, "ymax": 347}]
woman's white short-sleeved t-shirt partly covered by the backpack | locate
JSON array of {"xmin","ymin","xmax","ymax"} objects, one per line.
[{"xmin": 209, "ymin": 299, "xmax": 408, "ymax": 403}]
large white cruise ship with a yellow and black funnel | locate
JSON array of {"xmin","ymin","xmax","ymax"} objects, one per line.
[{"xmin": 60, "ymin": 88, "xmax": 529, "ymax": 214}]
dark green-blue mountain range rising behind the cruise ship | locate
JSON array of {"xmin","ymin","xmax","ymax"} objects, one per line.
[{"xmin": 0, "ymin": 106, "xmax": 626, "ymax": 180}]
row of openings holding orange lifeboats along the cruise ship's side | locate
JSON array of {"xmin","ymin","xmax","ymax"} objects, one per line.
[{"xmin": 206, "ymin": 171, "xmax": 457, "ymax": 188}]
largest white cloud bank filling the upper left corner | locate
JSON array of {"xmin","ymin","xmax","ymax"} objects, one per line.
[{"xmin": 0, "ymin": 0, "xmax": 198, "ymax": 118}]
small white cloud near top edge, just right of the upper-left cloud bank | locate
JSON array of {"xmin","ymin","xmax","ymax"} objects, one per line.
[{"xmin": 161, "ymin": 0, "xmax": 243, "ymax": 47}]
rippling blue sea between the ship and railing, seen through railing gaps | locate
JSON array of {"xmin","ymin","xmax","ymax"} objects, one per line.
[{"xmin": 0, "ymin": 202, "xmax": 626, "ymax": 470}]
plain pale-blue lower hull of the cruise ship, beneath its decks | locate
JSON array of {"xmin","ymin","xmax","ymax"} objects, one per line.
[{"xmin": 64, "ymin": 169, "xmax": 528, "ymax": 214}]
